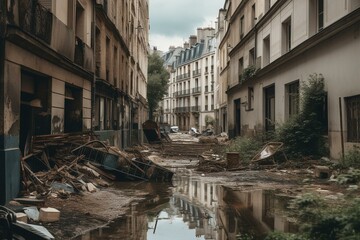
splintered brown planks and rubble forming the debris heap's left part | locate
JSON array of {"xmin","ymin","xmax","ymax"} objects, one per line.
[{"xmin": 21, "ymin": 133, "xmax": 115, "ymax": 198}]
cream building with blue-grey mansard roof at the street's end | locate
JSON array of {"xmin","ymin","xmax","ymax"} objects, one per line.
[{"xmin": 161, "ymin": 28, "xmax": 216, "ymax": 131}]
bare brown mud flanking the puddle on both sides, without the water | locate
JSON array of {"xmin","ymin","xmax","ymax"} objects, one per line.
[{"xmin": 35, "ymin": 145, "xmax": 359, "ymax": 239}]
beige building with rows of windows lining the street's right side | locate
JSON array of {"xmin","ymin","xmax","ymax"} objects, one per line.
[{"xmin": 219, "ymin": 0, "xmax": 360, "ymax": 158}]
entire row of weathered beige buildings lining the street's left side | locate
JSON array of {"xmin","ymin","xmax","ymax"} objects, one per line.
[{"xmin": 0, "ymin": 0, "xmax": 148, "ymax": 204}]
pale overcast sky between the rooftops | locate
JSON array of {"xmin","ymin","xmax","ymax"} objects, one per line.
[{"xmin": 149, "ymin": 0, "xmax": 225, "ymax": 51}]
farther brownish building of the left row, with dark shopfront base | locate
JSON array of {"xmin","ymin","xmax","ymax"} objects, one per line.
[{"xmin": 94, "ymin": 0, "xmax": 149, "ymax": 148}]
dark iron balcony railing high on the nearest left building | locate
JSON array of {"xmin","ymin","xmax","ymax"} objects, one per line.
[{"xmin": 19, "ymin": 0, "xmax": 52, "ymax": 44}]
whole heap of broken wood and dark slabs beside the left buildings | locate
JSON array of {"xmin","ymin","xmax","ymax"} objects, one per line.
[{"xmin": 21, "ymin": 133, "xmax": 173, "ymax": 198}]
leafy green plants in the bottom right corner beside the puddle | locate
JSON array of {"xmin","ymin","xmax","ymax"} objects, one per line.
[{"xmin": 266, "ymin": 194, "xmax": 360, "ymax": 240}]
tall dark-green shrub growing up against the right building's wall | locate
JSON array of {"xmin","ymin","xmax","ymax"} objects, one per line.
[{"xmin": 276, "ymin": 74, "xmax": 327, "ymax": 158}]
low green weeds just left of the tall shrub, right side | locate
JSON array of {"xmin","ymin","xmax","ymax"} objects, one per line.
[{"xmin": 223, "ymin": 137, "xmax": 262, "ymax": 163}]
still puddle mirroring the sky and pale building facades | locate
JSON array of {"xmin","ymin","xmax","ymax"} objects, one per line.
[{"xmin": 77, "ymin": 173, "xmax": 298, "ymax": 240}]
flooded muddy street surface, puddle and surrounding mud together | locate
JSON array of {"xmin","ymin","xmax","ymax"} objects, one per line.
[{"xmin": 41, "ymin": 151, "xmax": 348, "ymax": 240}]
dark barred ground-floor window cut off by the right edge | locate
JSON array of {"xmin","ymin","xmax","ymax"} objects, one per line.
[{"xmin": 345, "ymin": 95, "xmax": 360, "ymax": 142}]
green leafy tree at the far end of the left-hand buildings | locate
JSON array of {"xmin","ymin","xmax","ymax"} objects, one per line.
[{"xmin": 147, "ymin": 52, "xmax": 169, "ymax": 119}]
